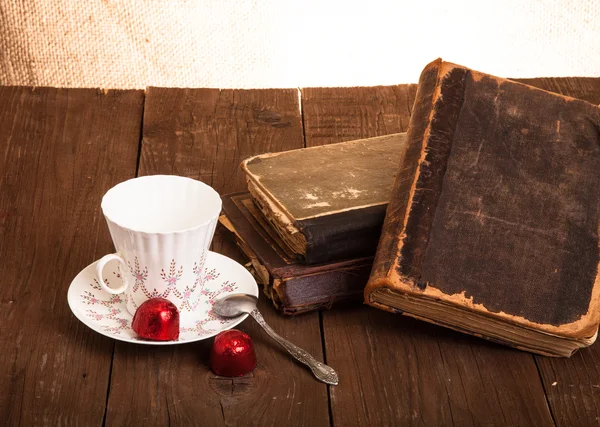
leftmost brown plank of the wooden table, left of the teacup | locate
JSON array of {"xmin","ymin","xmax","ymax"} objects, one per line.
[{"xmin": 0, "ymin": 87, "xmax": 143, "ymax": 426}]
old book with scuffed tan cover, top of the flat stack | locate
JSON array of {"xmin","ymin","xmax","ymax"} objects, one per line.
[{"xmin": 241, "ymin": 133, "xmax": 406, "ymax": 264}]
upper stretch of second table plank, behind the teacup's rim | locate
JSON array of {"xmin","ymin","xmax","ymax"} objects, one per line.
[{"xmin": 140, "ymin": 88, "xmax": 304, "ymax": 193}]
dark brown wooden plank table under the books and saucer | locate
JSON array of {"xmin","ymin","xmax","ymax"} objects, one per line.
[{"xmin": 0, "ymin": 78, "xmax": 600, "ymax": 426}]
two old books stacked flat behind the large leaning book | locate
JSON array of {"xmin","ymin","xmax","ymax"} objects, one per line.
[{"xmin": 220, "ymin": 133, "xmax": 406, "ymax": 314}]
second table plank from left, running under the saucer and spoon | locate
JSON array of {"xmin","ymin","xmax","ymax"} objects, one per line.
[{"xmin": 106, "ymin": 88, "xmax": 329, "ymax": 426}]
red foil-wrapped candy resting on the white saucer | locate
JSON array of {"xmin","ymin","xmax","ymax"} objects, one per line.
[{"xmin": 131, "ymin": 298, "xmax": 179, "ymax": 341}]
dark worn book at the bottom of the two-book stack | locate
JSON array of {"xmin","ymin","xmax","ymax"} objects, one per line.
[{"xmin": 219, "ymin": 193, "xmax": 373, "ymax": 315}]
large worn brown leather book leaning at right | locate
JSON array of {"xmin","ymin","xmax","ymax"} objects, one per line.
[{"xmin": 365, "ymin": 60, "xmax": 600, "ymax": 356}]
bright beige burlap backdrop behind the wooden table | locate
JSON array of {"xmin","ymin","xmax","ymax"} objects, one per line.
[{"xmin": 0, "ymin": 0, "xmax": 600, "ymax": 88}]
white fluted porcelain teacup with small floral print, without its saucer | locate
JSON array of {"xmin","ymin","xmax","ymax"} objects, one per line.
[{"xmin": 96, "ymin": 175, "xmax": 221, "ymax": 319}]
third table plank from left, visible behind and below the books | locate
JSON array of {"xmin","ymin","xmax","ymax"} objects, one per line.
[{"xmin": 310, "ymin": 85, "xmax": 552, "ymax": 426}]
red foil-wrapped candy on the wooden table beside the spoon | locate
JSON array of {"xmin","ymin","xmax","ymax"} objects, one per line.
[{"xmin": 210, "ymin": 329, "xmax": 256, "ymax": 377}]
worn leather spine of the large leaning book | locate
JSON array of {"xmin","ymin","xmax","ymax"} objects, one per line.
[{"xmin": 365, "ymin": 60, "xmax": 468, "ymax": 302}]
